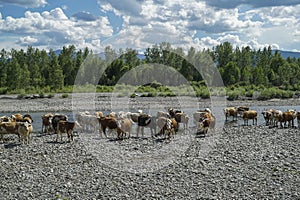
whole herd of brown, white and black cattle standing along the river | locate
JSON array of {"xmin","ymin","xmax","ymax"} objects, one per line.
[{"xmin": 0, "ymin": 106, "xmax": 300, "ymax": 144}]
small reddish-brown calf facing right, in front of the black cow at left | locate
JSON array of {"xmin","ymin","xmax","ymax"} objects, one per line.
[{"xmin": 56, "ymin": 120, "xmax": 80, "ymax": 142}]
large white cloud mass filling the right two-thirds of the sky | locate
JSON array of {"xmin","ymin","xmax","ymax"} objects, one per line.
[{"xmin": 98, "ymin": 0, "xmax": 300, "ymax": 49}]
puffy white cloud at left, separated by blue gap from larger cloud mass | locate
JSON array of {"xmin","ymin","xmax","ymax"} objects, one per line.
[{"xmin": 0, "ymin": 8, "xmax": 113, "ymax": 48}]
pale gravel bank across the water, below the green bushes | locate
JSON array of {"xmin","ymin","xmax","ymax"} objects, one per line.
[{"xmin": 0, "ymin": 93, "xmax": 300, "ymax": 112}]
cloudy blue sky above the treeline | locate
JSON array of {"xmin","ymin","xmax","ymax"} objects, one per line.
[{"xmin": 0, "ymin": 0, "xmax": 300, "ymax": 52}]
